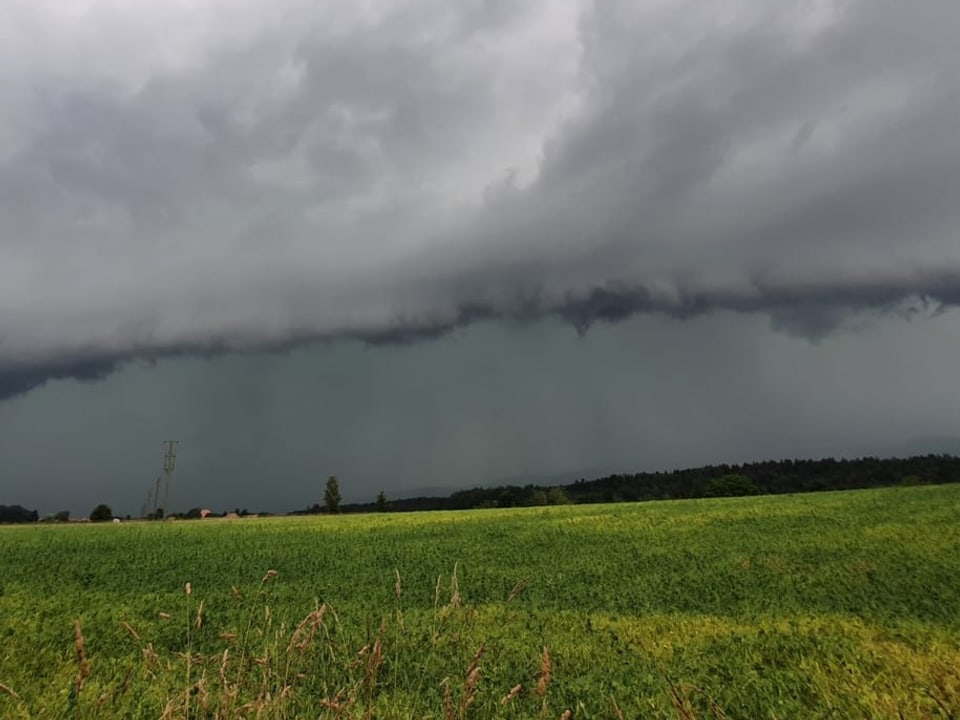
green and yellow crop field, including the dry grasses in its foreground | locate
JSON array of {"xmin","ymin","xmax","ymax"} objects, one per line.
[{"xmin": 0, "ymin": 486, "xmax": 960, "ymax": 720}]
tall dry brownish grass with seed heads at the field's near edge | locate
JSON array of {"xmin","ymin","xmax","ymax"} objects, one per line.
[{"xmin": 18, "ymin": 568, "xmax": 726, "ymax": 720}]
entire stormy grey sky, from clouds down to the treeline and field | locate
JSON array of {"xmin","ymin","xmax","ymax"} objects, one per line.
[{"xmin": 0, "ymin": 0, "xmax": 960, "ymax": 514}]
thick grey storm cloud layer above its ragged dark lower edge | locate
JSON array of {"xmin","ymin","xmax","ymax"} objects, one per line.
[{"xmin": 0, "ymin": 0, "xmax": 960, "ymax": 398}]
